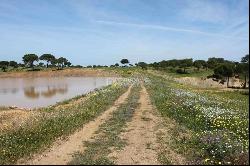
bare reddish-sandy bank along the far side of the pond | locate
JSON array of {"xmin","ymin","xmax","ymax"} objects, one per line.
[{"xmin": 0, "ymin": 68, "xmax": 118, "ymax": 78}]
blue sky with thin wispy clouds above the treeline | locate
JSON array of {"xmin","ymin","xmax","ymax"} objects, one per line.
[{"xmin": 0, "ymin": 0, "xmax": 249, "ymax": 65}]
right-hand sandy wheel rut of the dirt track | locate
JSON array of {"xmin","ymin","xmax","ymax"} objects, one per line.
[{"xmin": 109, "ymin": 86, "xmax": 184, "ymax": 165}]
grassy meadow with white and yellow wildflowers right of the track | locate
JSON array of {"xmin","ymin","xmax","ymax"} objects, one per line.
[{"xmin": 146, "ymin": 75, "xmax": 249, "ymax": 164}]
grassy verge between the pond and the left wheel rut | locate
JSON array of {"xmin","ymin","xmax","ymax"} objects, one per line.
[{"xmin": 0, "ymin": 80, "xmax": 131, "ymax": 164}]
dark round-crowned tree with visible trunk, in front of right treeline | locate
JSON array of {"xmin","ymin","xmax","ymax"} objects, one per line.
[{"xmin": 214, "ymin": 64, "xmax": 233, "ymax": 87}]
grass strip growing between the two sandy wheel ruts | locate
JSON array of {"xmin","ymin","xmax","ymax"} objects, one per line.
[{"xmin": 69, "ymin": 86, "xmax": 140, "ymax": 165}]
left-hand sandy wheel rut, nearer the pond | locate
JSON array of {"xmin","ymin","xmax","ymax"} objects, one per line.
[{"xmin": 17, "ymin": 87, "xmax": 131, "ymax": 165}]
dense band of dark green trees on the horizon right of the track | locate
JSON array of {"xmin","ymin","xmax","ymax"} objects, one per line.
[{"xmin": 136, "ymin": 54, "xmax": 249, "ymax": 87}]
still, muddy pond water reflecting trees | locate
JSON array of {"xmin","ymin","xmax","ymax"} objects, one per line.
[{"xmin": 0, "ymin": 77, "xmax": 115, "ymax": 108}]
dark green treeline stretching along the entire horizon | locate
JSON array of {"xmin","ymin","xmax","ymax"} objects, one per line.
[{"xmin": 0, "ymin": 54, "xmax": 249, "ymax": 87}]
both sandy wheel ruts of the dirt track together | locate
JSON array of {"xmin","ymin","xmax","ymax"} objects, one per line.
[{"xmin": 18, "ymin": 83, "xmax": 186, "ymax": 165}]
